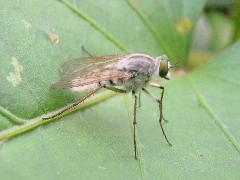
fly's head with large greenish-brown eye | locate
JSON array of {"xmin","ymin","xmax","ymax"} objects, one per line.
[{"xmin": 157, "ymin": 55, "xmax": 173, "ymax": 80}]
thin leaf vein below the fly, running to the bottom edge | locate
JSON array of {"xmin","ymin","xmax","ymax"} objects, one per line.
[{"xmin": 124, "ymin": 96, "xmax": 147, "ymax": 180}]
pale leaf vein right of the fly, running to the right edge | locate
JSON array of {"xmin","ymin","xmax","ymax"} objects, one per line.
[{"xmin": 186, "ymin": 76, "xmax": 240, "ymax": 154}]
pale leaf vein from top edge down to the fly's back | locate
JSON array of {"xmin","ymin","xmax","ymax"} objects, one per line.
[{"xmin": 60, "ymin": 0, "xmax": 128, "ymax": 53}]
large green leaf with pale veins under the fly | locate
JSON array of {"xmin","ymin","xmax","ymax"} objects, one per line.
[{"xmin": 0, "ymin": 0, "xmax": 240, "ymax": 179}]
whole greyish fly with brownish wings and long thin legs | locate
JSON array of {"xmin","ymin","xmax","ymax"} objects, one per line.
[{"xmin": 43, "ymin": 47, "xmax": 173, "ymax": 159}]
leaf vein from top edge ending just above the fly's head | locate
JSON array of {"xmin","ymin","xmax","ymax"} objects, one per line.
[{"xmin": 127, "ymin": 0, "xmax": 173, "ymax": 57}]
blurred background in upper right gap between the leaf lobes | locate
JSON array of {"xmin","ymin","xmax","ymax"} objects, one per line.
[{"xmin": 188, "ymin": 0, "xmax": 240, "ymax": 69}]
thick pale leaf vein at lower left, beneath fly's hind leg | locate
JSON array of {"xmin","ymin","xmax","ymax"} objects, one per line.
[{"xmin": 0, "ymin": 92, "xmax": 117, "ymax": 141}]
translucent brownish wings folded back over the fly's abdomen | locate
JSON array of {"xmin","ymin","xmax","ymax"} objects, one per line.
[{"xmin": 53, "ymin": 55, "xmax": 131, "ymax": 90}]
